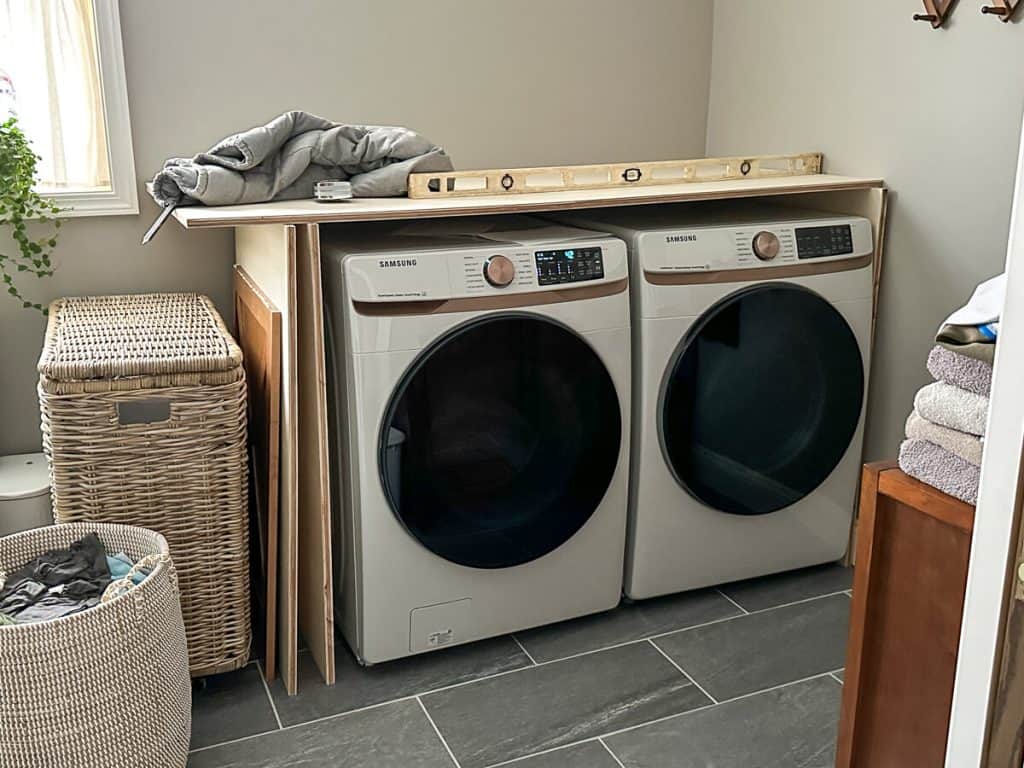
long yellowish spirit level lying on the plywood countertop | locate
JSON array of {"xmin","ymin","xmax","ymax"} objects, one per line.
[{"xmin": 409, "ymin": 153, "xmax": 822, "ymax": 199}]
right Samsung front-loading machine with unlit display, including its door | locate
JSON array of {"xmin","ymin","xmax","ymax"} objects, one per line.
[{"xmin": 557, "ymin": 202, "xmax": 873, "ymax": 599}]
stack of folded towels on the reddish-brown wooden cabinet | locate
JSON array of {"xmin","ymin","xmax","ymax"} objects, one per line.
[{"xmin": 899, "ymin": 275, "xmax": 1006, "ymax": 504}]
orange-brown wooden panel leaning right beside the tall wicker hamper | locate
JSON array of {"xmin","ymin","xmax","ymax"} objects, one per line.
[{"xmin": 234, "ymin": 264, "xmax": 281, "ymax": 680}]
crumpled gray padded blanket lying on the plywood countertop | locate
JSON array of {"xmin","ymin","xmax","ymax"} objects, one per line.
[{"xmin": 153, "ymin": 112, "xmax": 453, "ymax": 206}]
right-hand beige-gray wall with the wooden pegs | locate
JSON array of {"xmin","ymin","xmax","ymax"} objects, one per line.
[{"xmin": 708, "ymin": 0, "xmax": 1024, "ymax": 459}]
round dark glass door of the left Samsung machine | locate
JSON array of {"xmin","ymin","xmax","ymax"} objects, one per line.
[{"xmin": 380, "ymin": 313, "xmax": 622, "ymax": 568}]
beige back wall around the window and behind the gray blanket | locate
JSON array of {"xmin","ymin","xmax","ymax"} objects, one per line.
[{"xmin": 0, "ymin": 0, "xmax": 712, "ymax": 453}]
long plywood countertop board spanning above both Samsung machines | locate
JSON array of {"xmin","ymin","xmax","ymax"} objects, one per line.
[{"xmin": 174, "ymin": 174, "xmax": 885, "ymax": 228}]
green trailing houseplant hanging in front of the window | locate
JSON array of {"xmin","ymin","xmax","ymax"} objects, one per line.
[{"xmin": 0, "ymin": 118, "xmax": 61, "ymax": 314}]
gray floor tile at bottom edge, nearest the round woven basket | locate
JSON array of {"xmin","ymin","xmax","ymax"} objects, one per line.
[{"xmin": 188, "ymin": 700, "xmax": 453, "ymax": 768}]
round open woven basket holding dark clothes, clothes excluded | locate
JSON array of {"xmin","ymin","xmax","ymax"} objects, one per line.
[{"xmin": 0, "ymin": 523, "xmax": 191, "ymax": 768}]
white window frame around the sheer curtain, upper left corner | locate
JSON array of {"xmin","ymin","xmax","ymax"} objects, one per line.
[{"xmin": 42, "ymin": 0, "xmax": 138, "ymax": 217}]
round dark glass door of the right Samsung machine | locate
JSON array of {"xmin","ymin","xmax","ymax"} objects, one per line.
[{"xmin": 659, "ymin": 284, "xmax": 864, "ymax": 515}]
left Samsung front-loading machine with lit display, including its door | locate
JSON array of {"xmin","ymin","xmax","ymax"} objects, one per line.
[{"xmin": 323, "ymin": 217, "xmax": 631, "ymax": 664}]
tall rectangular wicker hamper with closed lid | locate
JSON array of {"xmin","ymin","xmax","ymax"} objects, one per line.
[{"xmin": 39, "ymin": 294, "xmax": 252, "ymax": 676}]
